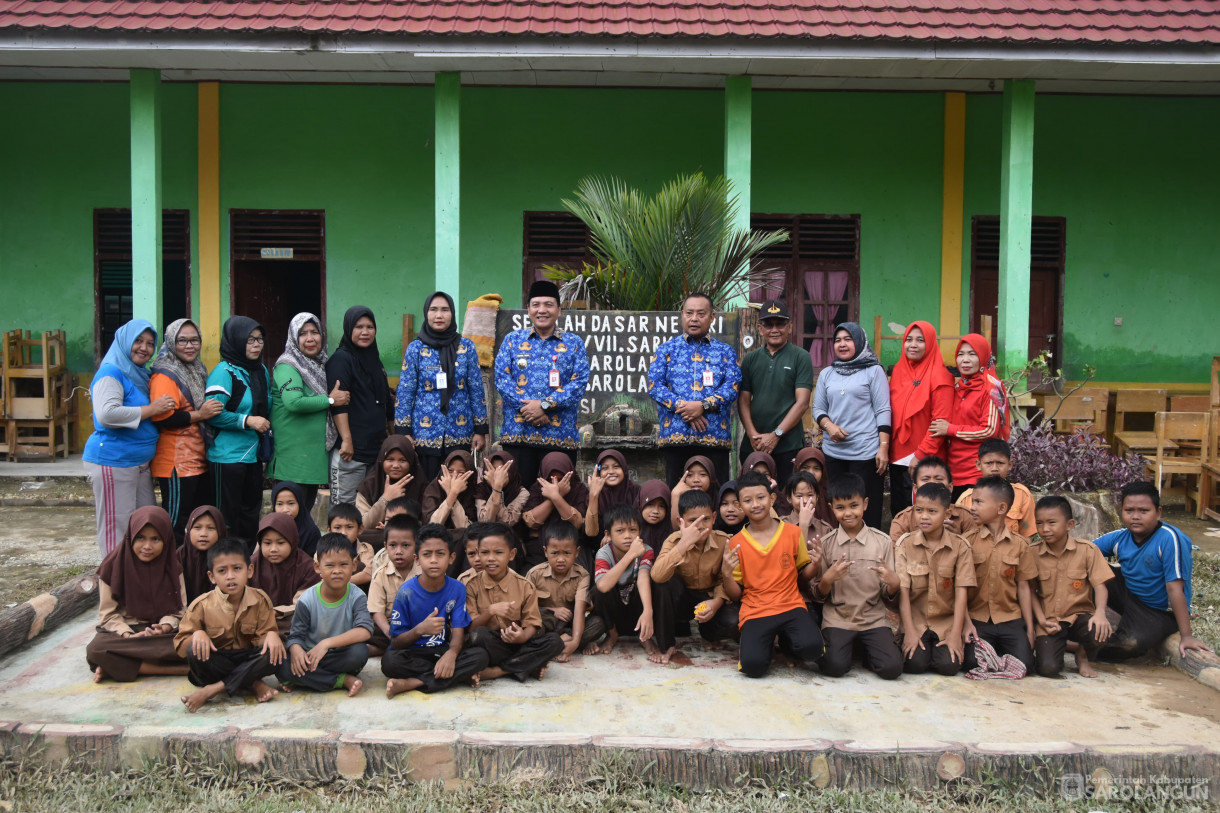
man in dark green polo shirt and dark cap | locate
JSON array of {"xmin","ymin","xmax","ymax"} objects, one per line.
[{"xmin": 737, "ymin": 299, "xmax": 814, "ymax": 488}]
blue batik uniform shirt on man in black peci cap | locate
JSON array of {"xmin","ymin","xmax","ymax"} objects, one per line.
[{"xmin": 495, "ymin": 327, "xmax": 589, "ymax": 449}]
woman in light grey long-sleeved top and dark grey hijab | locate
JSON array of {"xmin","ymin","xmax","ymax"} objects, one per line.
[{"xmin": 814, "ymin": 322, "xmax": 889, "ymax": 527}]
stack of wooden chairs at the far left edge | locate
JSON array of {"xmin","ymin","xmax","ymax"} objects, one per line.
[{"xmin": 2, "ymin": 330, "xmax": 76, "ymax": 460}]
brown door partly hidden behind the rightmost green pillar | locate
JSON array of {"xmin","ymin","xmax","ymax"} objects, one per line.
[{"xmin": 970, "ymin": 216, "xmax": 1066, "ymax": 367}]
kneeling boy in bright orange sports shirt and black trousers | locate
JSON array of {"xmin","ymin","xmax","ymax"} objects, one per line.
[{"xmin": 721, "ymin": 472, "xmax": 822, "ymax": 678}]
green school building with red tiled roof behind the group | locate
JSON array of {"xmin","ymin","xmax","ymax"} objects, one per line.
[{"xmin": 0, "ymin": 0, "xmax": 1220, "ymax": 439}]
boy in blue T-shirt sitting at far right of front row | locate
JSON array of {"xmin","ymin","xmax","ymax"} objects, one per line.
[{"xmin": 1093, "ymin": 480, "xmax": 1211, "ymax": 660}]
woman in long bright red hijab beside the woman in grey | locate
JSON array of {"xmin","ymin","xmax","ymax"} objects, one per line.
[{"xmin": 889, "ymin": 322, "xmax": 953, "ymax": 516}]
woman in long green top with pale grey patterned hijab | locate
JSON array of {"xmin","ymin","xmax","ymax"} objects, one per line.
[{"xmin": 267, "ymin": 314, "xmax": 350, "ymax": 511}]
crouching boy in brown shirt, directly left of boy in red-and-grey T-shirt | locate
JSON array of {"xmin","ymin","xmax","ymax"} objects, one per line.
[{"xmin": 526, "ymin": 522, "xmax": 606, "ymax": 663}]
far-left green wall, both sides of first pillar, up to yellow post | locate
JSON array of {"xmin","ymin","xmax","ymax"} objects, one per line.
[{"xmin": 0, "ymin": 82, "xmax": 198, "ymax": 371}]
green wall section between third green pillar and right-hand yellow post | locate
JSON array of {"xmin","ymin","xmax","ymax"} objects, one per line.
[{"xmin": 753, "ymin": 92, "xmax": 944, "ymax": 364}]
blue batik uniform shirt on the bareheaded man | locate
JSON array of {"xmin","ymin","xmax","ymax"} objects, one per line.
[{"xmin": 648, "ymin": 334, "xmax": 742, "ymax": 449}]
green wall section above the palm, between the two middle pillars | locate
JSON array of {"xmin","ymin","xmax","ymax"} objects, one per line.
[{"xmin": 459, "ymin": 88, "xmax": 725, "ymax": 309}]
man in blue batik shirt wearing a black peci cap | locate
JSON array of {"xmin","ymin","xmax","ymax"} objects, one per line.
[{"xmin": 495, "ymin": 280, "xmax": 589, "ymax": 486}]
